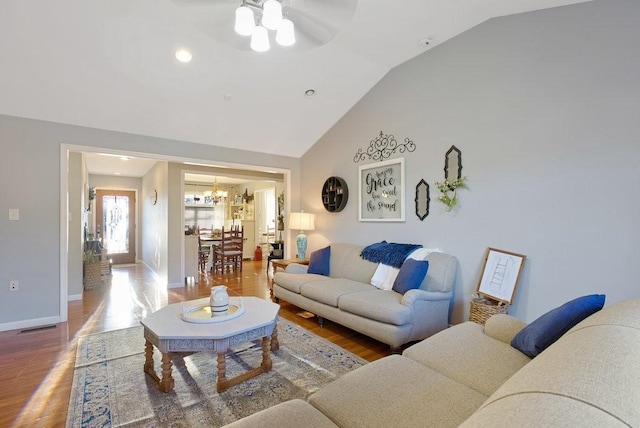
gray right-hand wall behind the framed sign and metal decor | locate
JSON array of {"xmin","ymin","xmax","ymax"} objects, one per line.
[{"xmin": 301, "ymin": 0, "xmax": 640, "ymax": 323}]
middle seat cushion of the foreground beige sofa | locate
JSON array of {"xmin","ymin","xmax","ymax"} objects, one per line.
[{"xmin": 308, "ymin": 355, "xmax": 485, "ymax": 428}]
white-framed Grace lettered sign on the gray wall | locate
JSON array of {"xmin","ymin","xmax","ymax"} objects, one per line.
[{"xmin": 358, "ymin": 158, "xmax": 405, "ymax": 221}]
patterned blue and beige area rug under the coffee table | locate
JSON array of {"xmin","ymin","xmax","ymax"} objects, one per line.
[{"xmin": 66, "ymin": 320, "xmax": 366, "ymax": 427}]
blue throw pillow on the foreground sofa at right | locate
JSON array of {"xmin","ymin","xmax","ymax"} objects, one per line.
[{"xmin": 511, "ymin": 294, "xmax": 605, "ymax": 358}]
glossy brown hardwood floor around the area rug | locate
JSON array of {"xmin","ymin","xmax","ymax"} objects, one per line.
[{"xmin": 0, "ymin": 261, "xmax": 390, "ymax": 427}]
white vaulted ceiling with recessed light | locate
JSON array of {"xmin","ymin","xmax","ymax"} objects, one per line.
[{"xmin": 0, "ymin": 0, "xmax": 584, "ymax": 157}]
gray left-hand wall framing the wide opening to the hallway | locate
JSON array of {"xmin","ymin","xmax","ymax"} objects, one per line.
[{"xmin": 0, "ymin": 115, "xmax": 300, "ymax": 331}]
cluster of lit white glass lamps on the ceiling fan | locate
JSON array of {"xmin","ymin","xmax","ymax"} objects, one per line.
[{"xmin": 234, "ymin": 0, "xmax": 296, "ymax": 52}]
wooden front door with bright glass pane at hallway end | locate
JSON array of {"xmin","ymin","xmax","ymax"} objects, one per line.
[{"xmin": 96, "ymin": 190, "xmax": 136, "ymax": 264}]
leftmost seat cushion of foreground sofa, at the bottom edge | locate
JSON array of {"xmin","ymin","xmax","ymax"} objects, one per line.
[{"xmin": 225, "ymin": 399, "xmax": 336, "ymax": 428}]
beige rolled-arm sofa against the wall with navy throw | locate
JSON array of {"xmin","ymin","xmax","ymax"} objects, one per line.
[{"xmin": 273, "ymin": 243, "xmax": 457, "ymax": 349}]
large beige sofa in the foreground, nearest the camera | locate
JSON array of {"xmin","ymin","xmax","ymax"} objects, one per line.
[{"xmin": 230, "ymin": 299, "xmax": 640, "ymax": 428}]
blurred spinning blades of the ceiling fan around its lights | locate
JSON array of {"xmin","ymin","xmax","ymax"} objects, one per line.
[{"xmin": 174, "ymin": 0, "xmax": 358, "ymax": 51}]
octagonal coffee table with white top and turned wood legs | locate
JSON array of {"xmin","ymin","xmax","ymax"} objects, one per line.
[{"xmin": 140, "ymin": 297, "xmax": 280, "ymax": 392}]
